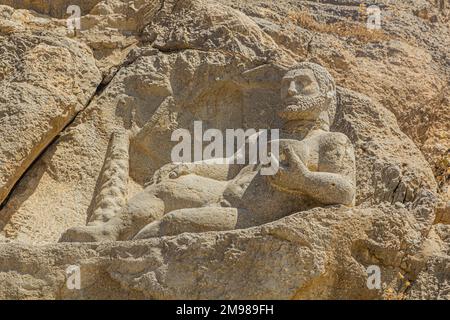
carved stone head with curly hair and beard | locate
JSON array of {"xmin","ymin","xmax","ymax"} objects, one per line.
[{"xmin": 279, "ymin": 62, "xmax": 337, "ymax": 128}]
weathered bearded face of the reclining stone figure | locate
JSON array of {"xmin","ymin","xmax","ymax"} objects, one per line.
[{"xmin": 279, "ymin": 69, "xmax": 327, "ymax": 121}]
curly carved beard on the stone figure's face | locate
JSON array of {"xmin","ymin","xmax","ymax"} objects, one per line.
[{"xmin": 278, "ymin": 95, "xmax": 328, "ymax": 121}]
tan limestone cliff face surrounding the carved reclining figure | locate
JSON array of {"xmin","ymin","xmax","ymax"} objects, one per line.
[{"xmin": 0, "ymin": 0, "xmax": 450, "ymax": 299}]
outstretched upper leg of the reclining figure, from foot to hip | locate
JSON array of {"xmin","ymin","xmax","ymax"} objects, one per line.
[{"xmin": 60, "ymin": 175, "xmax": 226, "ymax": 242}]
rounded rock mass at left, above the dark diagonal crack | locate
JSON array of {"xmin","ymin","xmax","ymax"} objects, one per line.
[{"xmin": 0, "ymin": 33, "xmax": 101, "ymax": 218}]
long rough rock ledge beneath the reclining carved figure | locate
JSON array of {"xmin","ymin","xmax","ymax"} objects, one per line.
[{"xmin": 0, "ymin": 202, "xmax": 438, "ymax": 299}]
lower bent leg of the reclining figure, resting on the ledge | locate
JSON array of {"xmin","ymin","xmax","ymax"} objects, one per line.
[{"xmin": 134, "ymin": 207, "xmax": 243, "ymax": 239}]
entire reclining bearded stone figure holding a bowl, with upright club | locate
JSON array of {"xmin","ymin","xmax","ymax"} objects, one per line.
[{"xmin": 61, "ymin": 62, "xmax": 355, "ymax": 241}]
